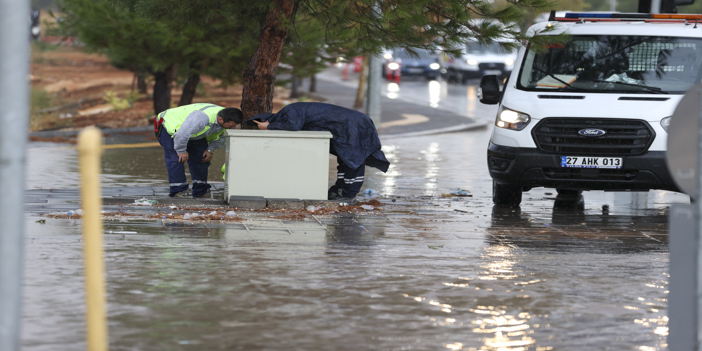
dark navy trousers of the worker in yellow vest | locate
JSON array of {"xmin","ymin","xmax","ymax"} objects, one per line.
[{"xmin": 158, "ymin": 129, "xmax": 212, "ymax": 197}]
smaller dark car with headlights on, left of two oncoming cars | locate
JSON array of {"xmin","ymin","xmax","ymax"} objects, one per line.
[{"xmin": 385, "ymin": 49, "xmax": 441, "ymax": 80}]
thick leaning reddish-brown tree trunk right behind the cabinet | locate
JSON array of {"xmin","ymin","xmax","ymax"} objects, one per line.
[{"xmin": 241, "ymin": 0, "xmax": 299, "ymax": 124}]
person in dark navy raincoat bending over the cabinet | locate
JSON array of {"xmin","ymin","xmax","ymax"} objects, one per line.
[{"xmin": 247, "ymin": 102, "xmax": 390, "ymax": 203}]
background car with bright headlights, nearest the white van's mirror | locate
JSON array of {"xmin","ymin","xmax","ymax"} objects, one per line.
[{"xmin": 442, "ymin": 42, "xmax": 517, "ymax": 84}]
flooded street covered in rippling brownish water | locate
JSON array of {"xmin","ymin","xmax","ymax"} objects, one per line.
[{"xmin": 22, "ymin": 71, "xmax": 689, "ymax": 350}]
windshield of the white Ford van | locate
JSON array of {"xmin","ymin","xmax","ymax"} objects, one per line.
[{"xmin": 517, "ymin": 35, "xmax": 702, "ymax": 94}]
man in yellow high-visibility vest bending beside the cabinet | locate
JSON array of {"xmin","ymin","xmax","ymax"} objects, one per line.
[{"xmin": 154, "ymin": 103, "xmax": 244, "ymax": 197}]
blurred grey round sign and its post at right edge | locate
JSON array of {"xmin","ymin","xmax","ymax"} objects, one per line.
[{"xmin": 666, "ymin": 84, "xmax": 702, "ymax": 351}]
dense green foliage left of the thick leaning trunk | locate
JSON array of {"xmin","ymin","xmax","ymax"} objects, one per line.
[{"xmin": 59, "ymin": 0, "xmax": 261, "ymax": 91}]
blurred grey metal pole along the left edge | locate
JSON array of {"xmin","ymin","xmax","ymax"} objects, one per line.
[{"xmin": 0, "ymin": 0, "xmax": 31, "ymax": 351}]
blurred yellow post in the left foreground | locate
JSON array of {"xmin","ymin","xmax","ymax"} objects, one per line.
[{"xmin": 78, "ymin": 127, "xmax": 107, "ymax": 351}]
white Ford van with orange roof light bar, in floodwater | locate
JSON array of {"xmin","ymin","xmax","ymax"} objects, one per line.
[{"xmin": 478, "ymin": 13, "xmax": 702, "ymax": 205}]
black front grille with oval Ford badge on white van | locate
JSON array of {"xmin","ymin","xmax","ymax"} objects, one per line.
[{"xmin": 532, "ymin": 118, "xmax": 656, "ymax": 156}]
